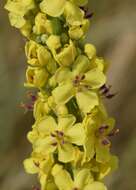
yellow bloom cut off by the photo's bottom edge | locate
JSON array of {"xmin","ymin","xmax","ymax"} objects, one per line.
[{"xmin": 52, "ymin": 164, "xmax": 107, "ymax": 190}]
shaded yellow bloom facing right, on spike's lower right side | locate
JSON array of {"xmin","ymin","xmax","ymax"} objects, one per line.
[{"xmin": 83, "ymin": 107, "xmax": 115, "ymax": 163}]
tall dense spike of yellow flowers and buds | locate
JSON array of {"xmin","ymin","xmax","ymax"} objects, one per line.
[{"xmin": 5, "ymin": 0, "xmax": 118, "ymax": 190}]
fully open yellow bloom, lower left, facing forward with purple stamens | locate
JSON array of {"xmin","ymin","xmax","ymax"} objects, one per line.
[{"xmin": 33, "ymin": 115, "xmax": 85, "ymax": 162}]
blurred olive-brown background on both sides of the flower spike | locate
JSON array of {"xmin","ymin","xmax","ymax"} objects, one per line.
[{"xmin": 0, "ymin": 0, "xmax": 136, "ymax": 190}]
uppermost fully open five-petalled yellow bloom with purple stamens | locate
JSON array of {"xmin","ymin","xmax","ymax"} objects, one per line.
[{"xmin": 52, "ymin": 55, "xmax": 106, "ymax": 113}]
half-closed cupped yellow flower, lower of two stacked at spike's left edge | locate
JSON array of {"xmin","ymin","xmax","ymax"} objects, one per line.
[{"xmin": 25, "ymin": 66, "xmax": 49, "ymax": 88}]
